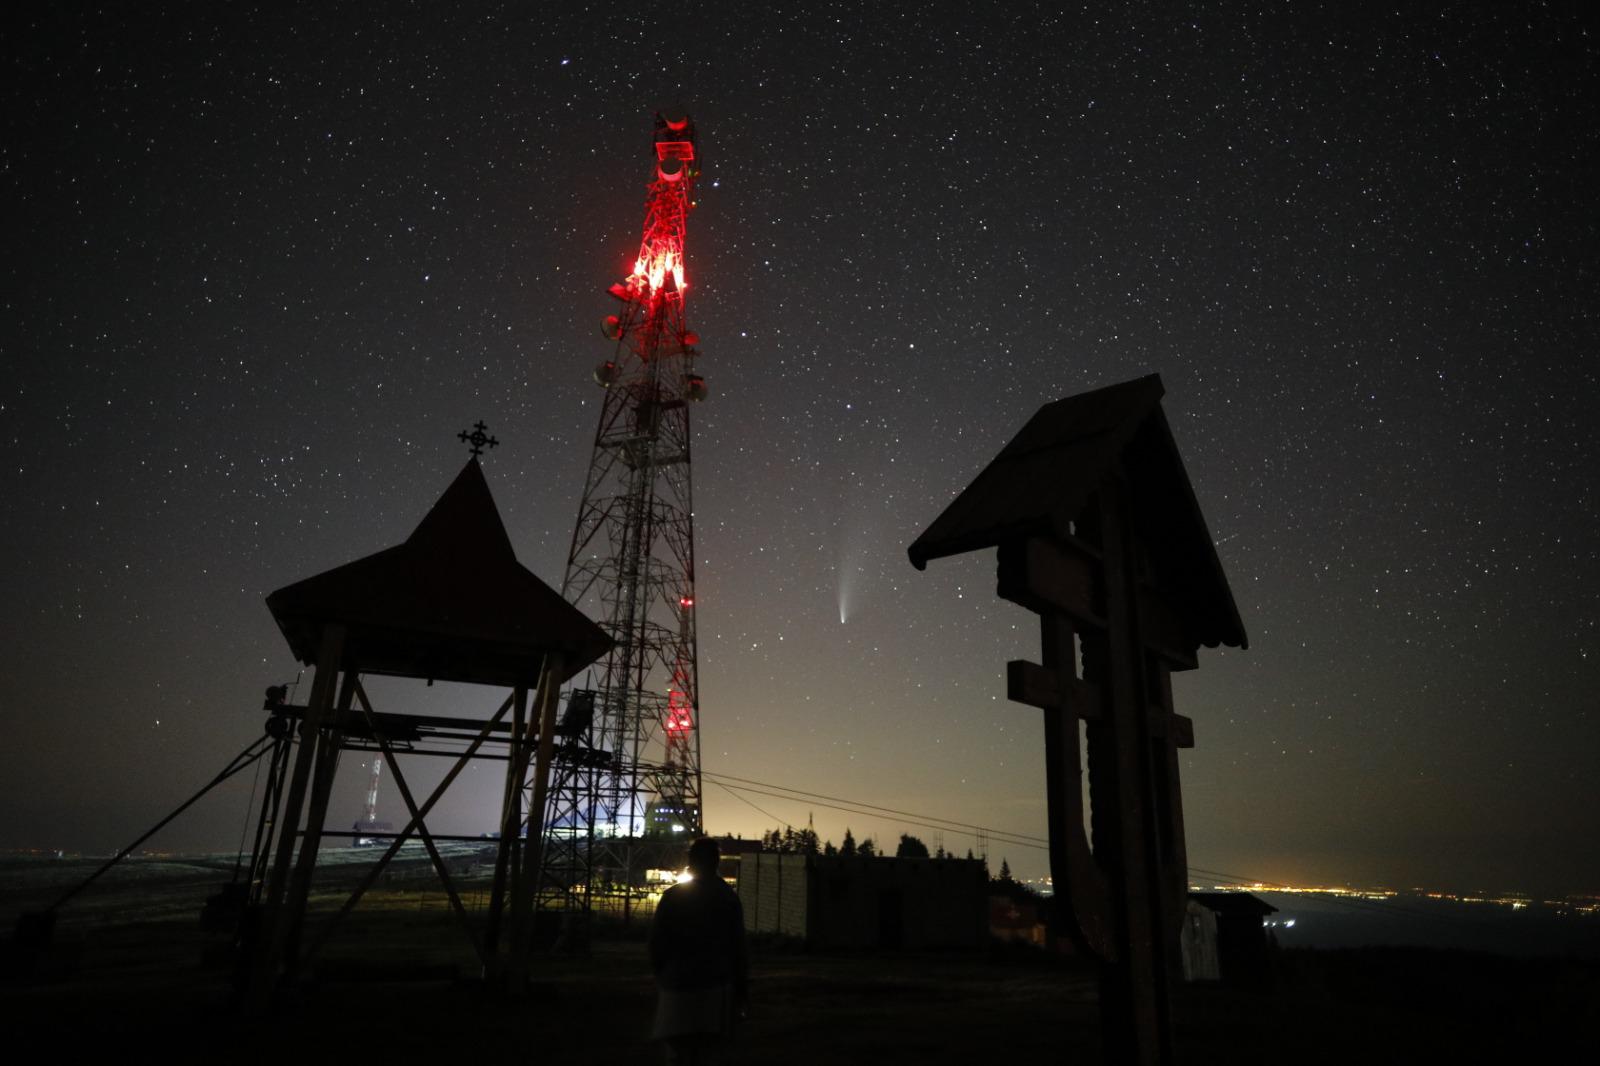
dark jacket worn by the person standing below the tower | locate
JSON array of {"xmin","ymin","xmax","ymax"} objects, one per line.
[{"xmin": 650, "ymin": 877, "xmax": 749, "ymax": 996}]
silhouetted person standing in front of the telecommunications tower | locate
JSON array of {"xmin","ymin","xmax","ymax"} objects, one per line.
[{"xmin": 650, "ymin": 837, "xmax": 749, "ymax": 1066}]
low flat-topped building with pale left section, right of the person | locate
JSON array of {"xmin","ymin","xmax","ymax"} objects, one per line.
[{"xmin": 739, "ymin": 852, "xmax": 989, "ymax": 948}]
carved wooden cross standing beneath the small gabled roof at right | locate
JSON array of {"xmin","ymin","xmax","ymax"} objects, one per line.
[{"xmin": 997, "ymin": 483, "xmax": 1194, "ymax": 1063}]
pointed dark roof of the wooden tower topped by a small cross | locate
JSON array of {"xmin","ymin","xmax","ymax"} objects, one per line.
[{"xmin": 267, "ymin": 458, "xmax": 611, "ymax": 685}]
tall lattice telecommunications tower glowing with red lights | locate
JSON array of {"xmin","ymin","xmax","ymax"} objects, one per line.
[{"xmin": 538, "ymin": 114, "xmax": 706, "ymax": 914}]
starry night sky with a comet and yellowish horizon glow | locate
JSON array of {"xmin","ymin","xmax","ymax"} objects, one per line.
[{"xmin": 0, "ymin": 2, "xmax": 1600, "ymax": 893}]
